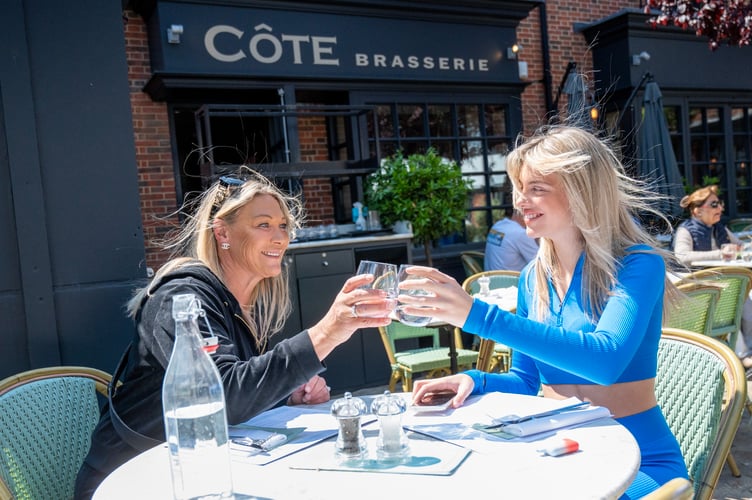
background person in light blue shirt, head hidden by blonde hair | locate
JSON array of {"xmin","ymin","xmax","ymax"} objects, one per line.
[{"xmin": 483, "ymin": 208, "xmax": 538, "ymax": 271}]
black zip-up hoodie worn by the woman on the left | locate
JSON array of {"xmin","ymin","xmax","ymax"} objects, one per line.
[{"xmin": 77, "ymin": 261, "xmax": 325, "ymax": 489}]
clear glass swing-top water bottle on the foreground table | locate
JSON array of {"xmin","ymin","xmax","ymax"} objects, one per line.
[{"xmin": 162, "ymin": 294, "xmax": 234, "ymax": 500}]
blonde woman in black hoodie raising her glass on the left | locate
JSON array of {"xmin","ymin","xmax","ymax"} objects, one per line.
[{"xmin": 75, "ymin": 168, "xmax": 393, "ymax": 498}]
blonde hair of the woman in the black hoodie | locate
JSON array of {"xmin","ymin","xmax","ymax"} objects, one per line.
[{"xmin": 127, "ymin": 166, "xmax": 303, "ymax": 349}]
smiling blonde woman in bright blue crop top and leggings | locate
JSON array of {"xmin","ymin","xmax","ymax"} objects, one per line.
[{"xmin": 400, "ymin": 126, "xmax": 687, "ymax": 499}]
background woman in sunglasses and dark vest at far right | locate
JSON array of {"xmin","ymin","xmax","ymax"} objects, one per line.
[{"xmin": 674, "ymin": 185, "xmax": 742, "ymax": 265}]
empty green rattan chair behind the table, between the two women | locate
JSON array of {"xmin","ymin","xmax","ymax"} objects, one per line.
[{"xmin": 379, "ymin": 321, "xmax": 478, "ymax": 392}]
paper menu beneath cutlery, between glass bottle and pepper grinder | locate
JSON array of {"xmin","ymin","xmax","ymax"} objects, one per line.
[{"xmin": 229, "ymin": 405, "xmax": 376, "ymax": 465}]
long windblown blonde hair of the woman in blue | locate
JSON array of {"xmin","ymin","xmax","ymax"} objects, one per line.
[{"xmin": 507, "ymin": 125, "xmax": 678, "ymax": 321}]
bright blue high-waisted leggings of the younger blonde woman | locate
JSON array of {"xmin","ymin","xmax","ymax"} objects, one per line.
[{"xmin": 616, "ymin": 406, "xmax": 688, "ymax": 500}]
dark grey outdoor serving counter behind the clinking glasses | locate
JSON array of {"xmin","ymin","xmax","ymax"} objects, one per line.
[{"xmin": 272, "ymin": 233, "xmax": 413, "ymax": 392}]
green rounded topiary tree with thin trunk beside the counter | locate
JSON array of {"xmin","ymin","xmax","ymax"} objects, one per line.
[{"xmin": 365, "ymin": 148, "xmax": 472, "ymax": 266}]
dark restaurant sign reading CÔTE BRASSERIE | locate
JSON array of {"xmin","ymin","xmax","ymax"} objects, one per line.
[{"xmin": 151, "ymin": 2, "xmax": 519, "ymax": 83}]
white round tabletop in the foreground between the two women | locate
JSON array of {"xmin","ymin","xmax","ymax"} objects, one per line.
[{"xmin": 94, "ymin": 395, "xmax": 640, "ymax": 500}]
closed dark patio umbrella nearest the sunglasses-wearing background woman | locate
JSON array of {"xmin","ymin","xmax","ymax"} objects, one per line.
[{"xmin": 637, "ymin": 78, "xmax": 684, "ymax": 216}]
